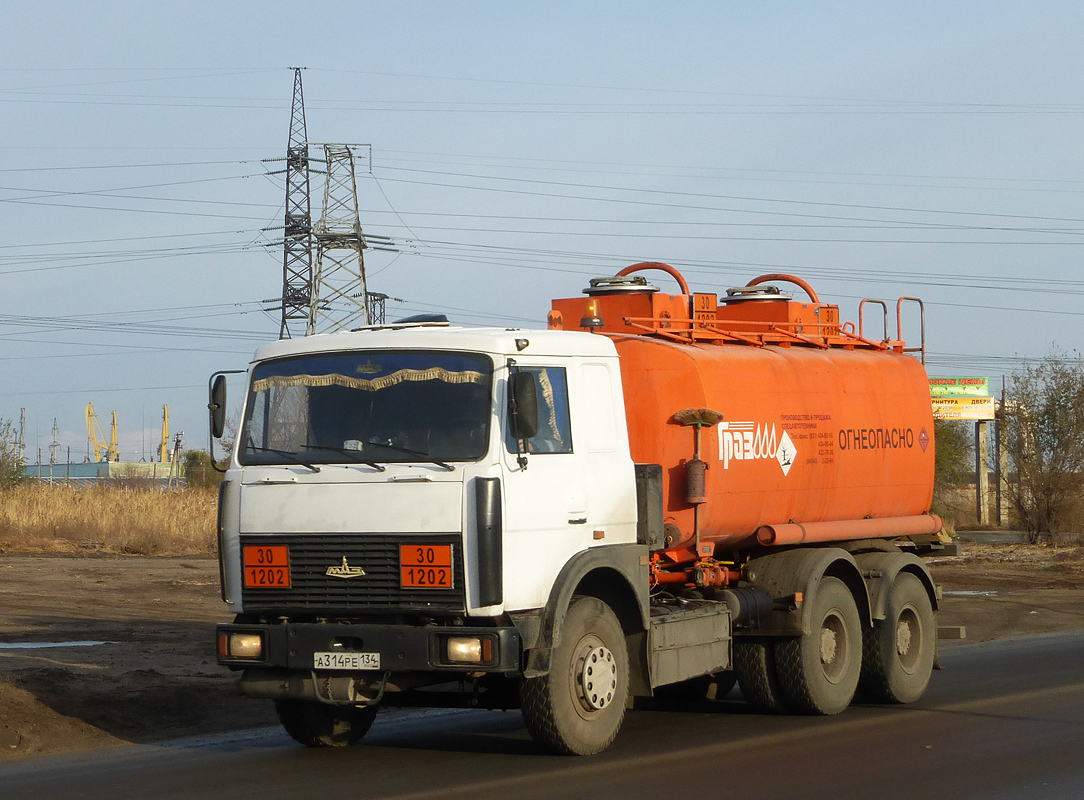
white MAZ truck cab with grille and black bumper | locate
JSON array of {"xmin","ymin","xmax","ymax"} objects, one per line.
[{"xmin": 218, "ymin": 324, "xmax": 648, "ymax": 744}]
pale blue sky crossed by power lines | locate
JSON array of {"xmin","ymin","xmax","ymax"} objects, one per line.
[{"xmin": 0, "ymin": 0, "xmax": 1084, "ymax": 462}]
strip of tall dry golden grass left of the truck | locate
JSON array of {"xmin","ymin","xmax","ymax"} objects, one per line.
[{"xmin": 0, "ymin": 485, "xmax": 217, "ymax": 555}]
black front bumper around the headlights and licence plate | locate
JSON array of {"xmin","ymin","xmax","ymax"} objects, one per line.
[{"xmin": 216, "ymin": 622, "xmax": 522, "ymax": 678}]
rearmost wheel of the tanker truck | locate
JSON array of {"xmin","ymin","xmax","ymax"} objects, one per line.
[{"xmin": 861, "ymin": 572, "xmax": 937, "ymax": 704}]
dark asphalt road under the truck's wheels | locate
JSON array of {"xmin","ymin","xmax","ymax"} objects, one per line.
[{"xmin": 0, "ymin": 633, "xmax": 1084, "ymax": 800}]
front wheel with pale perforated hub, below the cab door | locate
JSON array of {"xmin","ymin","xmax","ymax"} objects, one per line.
[{"xmin": 521, "ymin": 596, "xmax": 629, "ymax": 756}]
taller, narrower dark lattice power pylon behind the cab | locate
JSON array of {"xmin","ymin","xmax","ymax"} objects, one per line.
[{"xmin": 279, "ymin": 67, "xmax": 312, "ymax": 339}]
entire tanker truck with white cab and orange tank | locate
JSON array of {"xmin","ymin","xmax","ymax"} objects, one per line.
[{"xmin": 210, "ymin": 262, "xmax": 944, "ymax": 754}]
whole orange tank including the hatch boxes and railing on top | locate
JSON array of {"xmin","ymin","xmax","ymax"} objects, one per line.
[{"xmin": 550, "ymin": 264, "xmax": 940, "ymax": 551}]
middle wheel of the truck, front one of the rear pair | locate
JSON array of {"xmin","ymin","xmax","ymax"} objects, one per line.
[{"xmin": 775, "ymin": 578, "xmax": 862, "ymax": 714}]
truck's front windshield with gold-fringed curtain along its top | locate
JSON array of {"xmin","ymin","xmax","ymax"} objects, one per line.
[{"xmin": 238, "ymin": 350, "xmax": 493, "ymax": 465}]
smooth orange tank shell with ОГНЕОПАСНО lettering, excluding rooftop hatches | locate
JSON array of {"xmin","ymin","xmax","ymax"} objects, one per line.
[{"xmin": 616, "ymin": 336, "xmax": 933, "ymax": 543}]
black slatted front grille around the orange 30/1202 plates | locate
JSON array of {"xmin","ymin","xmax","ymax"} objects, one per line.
[{"xmin": 241, "ymin": 533, "xmax": 465, "ymax": 614}]
